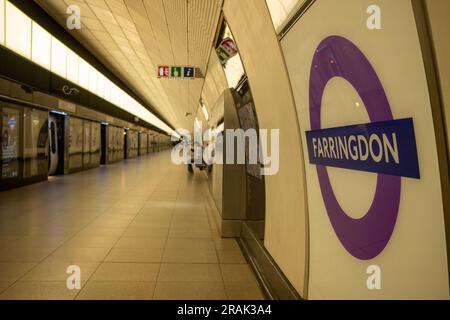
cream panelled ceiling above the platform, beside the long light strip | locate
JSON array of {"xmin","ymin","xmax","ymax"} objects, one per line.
[{"xmin": 35, "ymin": 0, "xmax": 223, "ymax": 129}]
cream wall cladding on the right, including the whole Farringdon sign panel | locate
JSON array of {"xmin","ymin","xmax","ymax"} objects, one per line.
[{"xmin": 223, "ymin": 0, "xmax": 449, "ymax": 299}]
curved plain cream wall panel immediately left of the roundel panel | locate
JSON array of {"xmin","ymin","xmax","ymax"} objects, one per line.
[{"xmin": 223, "ymin": 0, "xmax": 307, "ymax": 297}]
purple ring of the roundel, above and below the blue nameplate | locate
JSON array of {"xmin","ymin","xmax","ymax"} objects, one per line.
[{"xmin": 309, "ymin": 36, "xmax": 401, "ymax": 260}]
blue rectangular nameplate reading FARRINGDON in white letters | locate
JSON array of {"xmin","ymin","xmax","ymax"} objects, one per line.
[{"xmin": 306, "ymin": 119, "xmax": 420, "ymax": 179}]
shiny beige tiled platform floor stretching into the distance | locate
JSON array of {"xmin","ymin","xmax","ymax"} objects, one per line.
[{"xmin": 0, "ymin": 152, "xmax": 263, "ymax": 300}]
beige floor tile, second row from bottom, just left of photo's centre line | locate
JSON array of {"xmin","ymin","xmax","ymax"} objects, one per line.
[{"xmin": 158, "ymin": 263, "xmax": 222, "ymax": 282}]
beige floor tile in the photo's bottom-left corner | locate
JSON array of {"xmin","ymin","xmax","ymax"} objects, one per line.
[{"xmin": 0, "ymin": 282, "xmax": 79, "ymax": 300}]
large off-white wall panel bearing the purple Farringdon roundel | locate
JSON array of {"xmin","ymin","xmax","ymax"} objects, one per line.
[{"xmin": 281, "ymin": 0, "xmax": 449, "ymax": 300}]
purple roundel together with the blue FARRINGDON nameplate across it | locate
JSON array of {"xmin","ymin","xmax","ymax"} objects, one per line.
[{"xmin": 306, "ymin": 36, "xmax": 420, "ymax": 260}]
